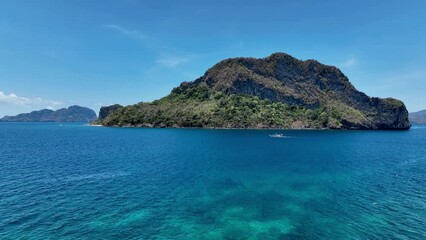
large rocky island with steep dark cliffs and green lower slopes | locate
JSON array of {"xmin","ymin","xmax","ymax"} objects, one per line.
[{"xmin": 94, "ymin": 53, "xmax": 411, "ymax": 129}]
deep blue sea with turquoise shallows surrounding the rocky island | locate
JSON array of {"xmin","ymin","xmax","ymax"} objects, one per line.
[{"xmin": 0, "ymin": 123, "xmax": 426, "ymax": 239}]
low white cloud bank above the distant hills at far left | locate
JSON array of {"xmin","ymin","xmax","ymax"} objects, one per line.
[{"xmin": 0, "ymin": 91, "xmax": 63, "ymax": 108}]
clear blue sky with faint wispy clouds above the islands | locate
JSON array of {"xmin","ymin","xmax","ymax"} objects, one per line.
[{"xmin": 0, "ymin": 0, "xmax": 426, "ymax": 117}]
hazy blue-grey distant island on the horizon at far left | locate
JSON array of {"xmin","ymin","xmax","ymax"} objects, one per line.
[{"xmin": 0, "ymin": 106, "xmax": 97, "ymax": 122}]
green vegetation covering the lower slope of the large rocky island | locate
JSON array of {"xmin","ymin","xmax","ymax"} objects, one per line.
[{"xmin": 96, "ymin": 86, "xmax": 341, "ymax": 128}]
